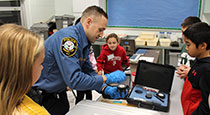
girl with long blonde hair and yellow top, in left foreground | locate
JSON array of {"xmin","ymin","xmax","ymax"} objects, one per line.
[{"xmin": 0, "ymin": 24, "xmax": 49, "ymax": 115}]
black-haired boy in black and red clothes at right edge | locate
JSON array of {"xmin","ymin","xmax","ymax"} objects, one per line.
[{"xmin": 181, "ymin": 22, "xmax": 210, "ymax": 115}]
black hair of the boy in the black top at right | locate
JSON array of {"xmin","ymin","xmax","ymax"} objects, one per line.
[{"xmin": 183, "ymin": 22, "xmax": 210, "ymax": 50}]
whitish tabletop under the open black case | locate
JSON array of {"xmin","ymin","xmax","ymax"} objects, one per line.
[{"xmin": 67, "ymin": 74, "xmax": 184, "ymax": 115}]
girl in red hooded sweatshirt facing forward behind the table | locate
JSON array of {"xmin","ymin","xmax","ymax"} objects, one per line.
[{"xmin": 97, "ymin": 33, "xmax": 130, "ymax": 75}]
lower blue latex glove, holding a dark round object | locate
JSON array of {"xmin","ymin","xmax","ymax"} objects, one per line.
[{"xmin": 104, "ymin": 86, "xmax": 128, "ymax": 99}]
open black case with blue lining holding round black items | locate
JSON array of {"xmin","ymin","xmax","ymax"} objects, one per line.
[{"xmin": 127, "ymin": 61, "xmax": 175, "ymax": 112}]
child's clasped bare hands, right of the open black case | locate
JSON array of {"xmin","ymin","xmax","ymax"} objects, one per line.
[{"xmin": 176, "ymin": 65, "xmax": 191, "ymax": 79}]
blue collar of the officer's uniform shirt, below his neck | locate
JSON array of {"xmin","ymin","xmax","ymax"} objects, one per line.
[{"xmin": 76, "ymin": 22, "xmax": 91, "ymax": 47}]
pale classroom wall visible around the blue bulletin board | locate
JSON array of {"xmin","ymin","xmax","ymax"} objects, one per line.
[{"xmin": 24, "ymin": 0, "xmax": 210, "ymax": 37}]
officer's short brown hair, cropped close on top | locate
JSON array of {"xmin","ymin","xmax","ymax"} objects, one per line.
[{"xmin": 81, "ymin": 6, "xmax": 108, "ymax": 20}]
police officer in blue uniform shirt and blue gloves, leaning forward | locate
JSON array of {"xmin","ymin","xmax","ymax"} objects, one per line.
[{"xmin": 29, "ymin": 6, "xmax": 126, "ymax": 115}]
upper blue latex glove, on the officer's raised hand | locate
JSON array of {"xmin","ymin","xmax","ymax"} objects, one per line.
[{"xmin": 105, "ymin": 70, "xmax": 126, "ymax": 84}]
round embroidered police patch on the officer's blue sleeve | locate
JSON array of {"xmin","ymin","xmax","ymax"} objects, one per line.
[{"xmin": 61, "ymin": 37, "xmax": 78, "ymax": 57}]
